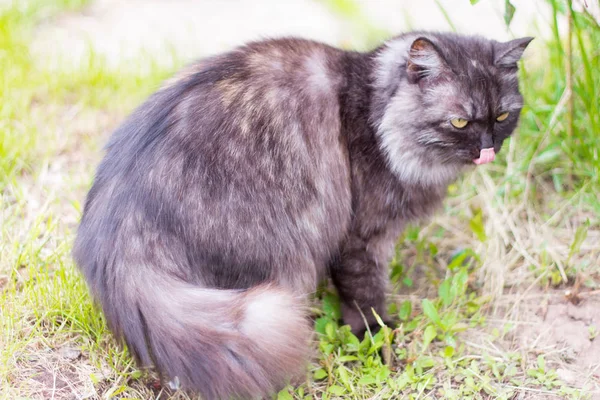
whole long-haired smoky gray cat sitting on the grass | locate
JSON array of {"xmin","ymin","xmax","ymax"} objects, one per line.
[{"xmin": 74, "ymin": 32, "xmax": 532, "ymax": 399}]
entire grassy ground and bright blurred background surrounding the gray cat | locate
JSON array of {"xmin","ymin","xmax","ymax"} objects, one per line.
[{"xmin": 0, "ymin": 0, "xmax": 600, "ymax": 400}]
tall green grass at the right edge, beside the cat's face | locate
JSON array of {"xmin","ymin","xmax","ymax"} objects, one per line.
[{"xmin": 519, "ymin": 0, "xmax": 600, "ymax": 200}]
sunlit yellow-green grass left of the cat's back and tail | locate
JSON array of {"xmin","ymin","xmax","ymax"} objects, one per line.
[{"xmin": 0, "ymin": 0, "xmax": 173, "ymax": 399}]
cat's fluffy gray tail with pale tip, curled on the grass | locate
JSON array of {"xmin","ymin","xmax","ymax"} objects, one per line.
[{"xmin": 100, "ymin": 274, "xmax": 311, "ymax": 400}]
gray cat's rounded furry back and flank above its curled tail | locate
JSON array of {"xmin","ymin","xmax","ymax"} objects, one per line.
[{"xmin": 79, "ymin": 39, "xmax": 351, "ymax": 287}]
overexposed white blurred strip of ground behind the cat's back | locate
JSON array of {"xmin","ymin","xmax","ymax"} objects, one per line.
[{"xmin": 34, "ymin": 0, "xmax": 600, "ymax": 69}]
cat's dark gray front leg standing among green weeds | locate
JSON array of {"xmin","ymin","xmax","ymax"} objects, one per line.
[{"xmin": 331, "ymin": 220, "xmax": 400, "ymax": 336}]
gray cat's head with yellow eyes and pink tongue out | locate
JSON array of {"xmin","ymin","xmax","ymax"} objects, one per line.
[{"xmin": 375, "ymin": 34, "xmax": 532, "ymax": 183}]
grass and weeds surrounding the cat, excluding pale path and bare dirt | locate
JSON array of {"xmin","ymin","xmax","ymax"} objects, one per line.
[{"xmin": 0, "ymin": 0, "xmax": 600, "ymax": 399}]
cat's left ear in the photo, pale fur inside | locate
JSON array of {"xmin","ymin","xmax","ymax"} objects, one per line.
[{"xmin": 406, "ymin": 37, "xmax": 447, "ymax": 83}]
